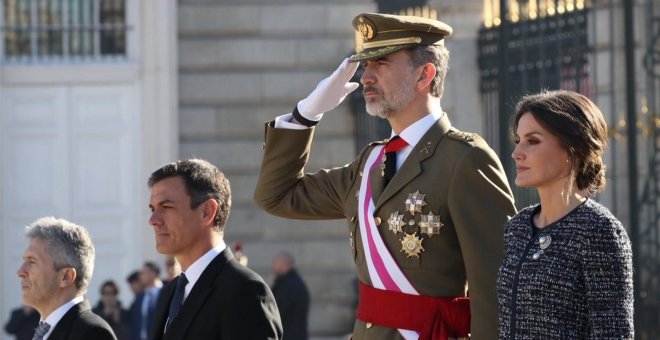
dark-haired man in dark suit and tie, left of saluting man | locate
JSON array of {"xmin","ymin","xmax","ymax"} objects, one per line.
[{"xmin": 148, "ymin": 159, "xmax": 282, "ymax": 340}]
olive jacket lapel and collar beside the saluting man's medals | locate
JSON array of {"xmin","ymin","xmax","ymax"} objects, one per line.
[{"xmin": 374, "ymin": 113, "xmax": 451, "ymax": 210}]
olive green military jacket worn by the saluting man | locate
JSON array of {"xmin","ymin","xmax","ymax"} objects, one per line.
[{"xmin": 254, "ymin": 114, "xmax": 515, "ymax": 340}]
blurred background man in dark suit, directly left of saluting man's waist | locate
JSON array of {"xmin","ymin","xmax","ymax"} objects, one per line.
[{"xmin": 272, "ymin": 252, "xmax": 309, "ymax": 340}]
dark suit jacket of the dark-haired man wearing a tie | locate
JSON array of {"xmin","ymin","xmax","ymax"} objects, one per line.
[{"xmin": 151, "ymin": 249, "xmax": 282, "ymax": 340}]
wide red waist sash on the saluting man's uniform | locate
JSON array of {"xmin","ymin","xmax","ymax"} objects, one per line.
[{"xmin": 357, "ymin": 282, "xmax": 470, "ymax": 340}]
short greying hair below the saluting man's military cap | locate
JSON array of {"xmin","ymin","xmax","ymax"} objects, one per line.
[{"xmin": 406, "ymin": 45, "xmax": 449, "ymax": 98}]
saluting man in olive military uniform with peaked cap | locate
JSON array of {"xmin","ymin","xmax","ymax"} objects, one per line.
[{"xmin": 254, "ymin": 13, "xmax": 515, "ymax": 339}]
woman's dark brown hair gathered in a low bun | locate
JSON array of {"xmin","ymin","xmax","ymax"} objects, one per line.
[{"xmin": 512, "ymin": 90, "xmax": 607, "ymax": 196}]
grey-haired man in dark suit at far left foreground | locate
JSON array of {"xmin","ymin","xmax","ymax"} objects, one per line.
[{"xmin": 17, "ymin": 217, "xmax": 116, "ymax": 340}]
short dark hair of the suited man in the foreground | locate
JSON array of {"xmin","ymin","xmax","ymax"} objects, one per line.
[{"xmin": 148, "ymin": 159, "xmax": 231, "ymax": 231}]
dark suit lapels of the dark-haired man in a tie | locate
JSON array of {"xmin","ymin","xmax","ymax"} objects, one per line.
[{"xmin": 160, "ymin": 248, "xmax": 234, "ymax": 340}]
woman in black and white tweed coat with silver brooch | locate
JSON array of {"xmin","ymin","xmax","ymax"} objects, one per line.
[{"xmin": 497, "ymin": 91, "xmax": 634, "ymax": 339}]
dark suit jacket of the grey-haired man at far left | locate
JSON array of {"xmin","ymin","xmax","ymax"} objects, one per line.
[{"xmin": 48, "ymin": 300, "xmax": 117, "ymax": 340}]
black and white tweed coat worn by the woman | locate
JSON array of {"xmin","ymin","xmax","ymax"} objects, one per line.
[{"xmin": 497, "ymin": 199, "xmax": 634, "ymax": 339}]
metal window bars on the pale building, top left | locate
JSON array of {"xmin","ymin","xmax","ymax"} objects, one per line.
[{"xmin": 0, "ymin": 0, "xmax": 129, "ymax": 64}]
